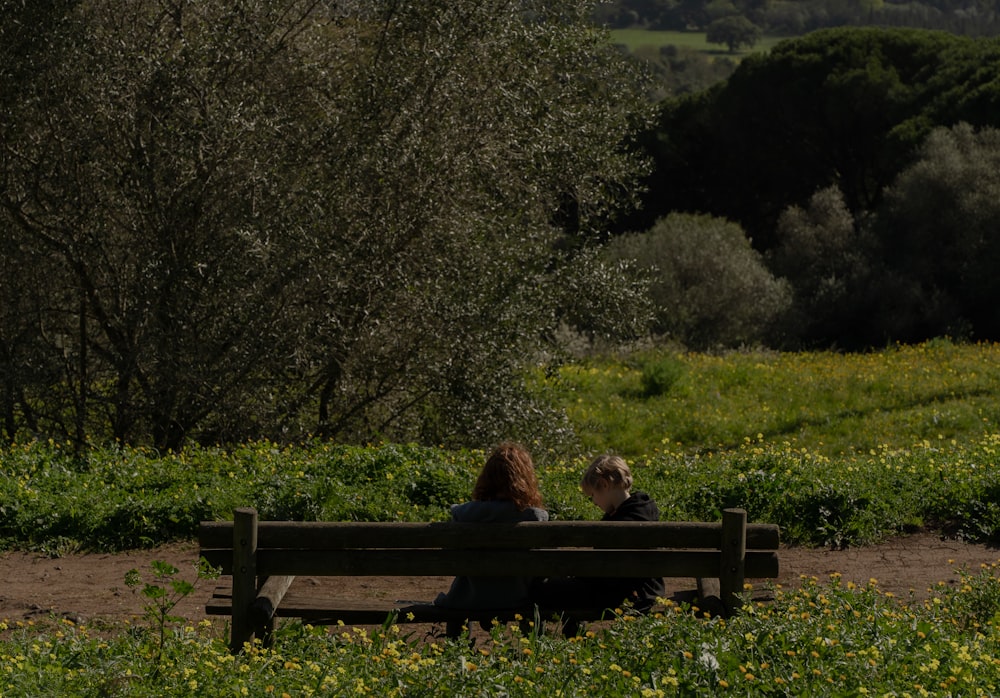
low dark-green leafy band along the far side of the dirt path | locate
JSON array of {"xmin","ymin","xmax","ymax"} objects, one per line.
[{"xmin": 0, "ymin": 436, "xmax": 1000, "ymax": 554}]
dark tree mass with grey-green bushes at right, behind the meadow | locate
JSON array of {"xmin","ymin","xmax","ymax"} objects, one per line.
[{"xmin": 609, "ymin": 28, "xmax": 1000, "ymax": 349}]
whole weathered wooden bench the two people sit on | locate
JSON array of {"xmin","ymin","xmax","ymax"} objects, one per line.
[{"xmin": 199, "ymin": 508, "xmax": 779, "ymax": 652}]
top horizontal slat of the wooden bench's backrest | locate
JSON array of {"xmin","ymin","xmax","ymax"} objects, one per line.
[{"xmin": 198, "ymin": 521, "xmax": 779, "ymax": 550}]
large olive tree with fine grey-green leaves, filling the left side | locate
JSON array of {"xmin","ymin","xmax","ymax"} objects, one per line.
[{"xmin": 0, "ymin": 0, "xmax": 651, "ymax": 447}]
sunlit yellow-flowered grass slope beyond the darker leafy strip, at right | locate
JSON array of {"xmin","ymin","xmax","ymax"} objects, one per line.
[{"xmin": 548, "ymin": 340, "xmax": 1000, "ymax": 458}]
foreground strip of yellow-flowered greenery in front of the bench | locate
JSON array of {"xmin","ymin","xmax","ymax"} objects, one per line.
[{"xmin": 0, "ymin": 566, "xmax": 1000, "ymax": 698}]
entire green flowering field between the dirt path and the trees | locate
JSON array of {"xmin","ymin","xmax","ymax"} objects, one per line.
[{"xmin": 0, "ymin": 341, "xmax": 1000, "ymax": 554}]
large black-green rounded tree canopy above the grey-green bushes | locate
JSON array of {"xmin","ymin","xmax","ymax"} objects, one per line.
[{"xmin": 647, "ymin": 28, "xmax": 997, "ymax": 250}]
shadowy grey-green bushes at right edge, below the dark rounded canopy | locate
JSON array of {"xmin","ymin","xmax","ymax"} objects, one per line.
[{"xmin": 766, "ymin": 122, "xmax": 1000, "ymax": 347}]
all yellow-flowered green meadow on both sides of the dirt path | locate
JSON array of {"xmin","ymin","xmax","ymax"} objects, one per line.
[{"xmin": 0, "ymin": 341, "xmax": 1000, "ymax": 697}]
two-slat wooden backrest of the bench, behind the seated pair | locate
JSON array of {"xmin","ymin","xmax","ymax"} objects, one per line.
[{"xmin": 199, "ymin": 506, "xmax": 779, "ymax": 578}]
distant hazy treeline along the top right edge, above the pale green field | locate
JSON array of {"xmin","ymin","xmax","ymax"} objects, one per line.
[{"xmin": 596, "ymin": 0, "xmax": 1000, "ymax": 36}]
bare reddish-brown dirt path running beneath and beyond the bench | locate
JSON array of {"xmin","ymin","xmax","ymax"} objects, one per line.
[{"xmin": 0, "ymin": 533, "xmax": 1000, "ymax": 623}]
